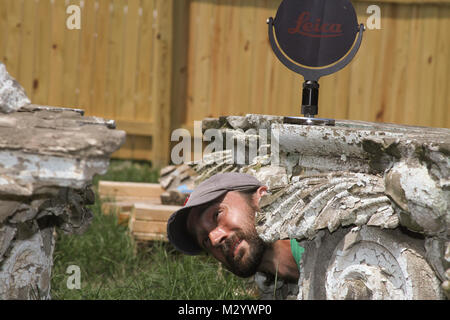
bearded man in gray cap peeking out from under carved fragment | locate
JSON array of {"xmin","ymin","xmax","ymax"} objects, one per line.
[{"xmin": 167, "ymin": 173, "xmax": 303, "ymax": 290}]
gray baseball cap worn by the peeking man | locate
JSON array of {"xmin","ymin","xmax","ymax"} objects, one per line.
[{"xmin": 167, "ymin": 172, "xmax": 263, "ymax": 255}]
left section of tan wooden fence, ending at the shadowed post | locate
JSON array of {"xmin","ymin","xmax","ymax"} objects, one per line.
[{"xmin": 0, "ymin": 0, "xmax": 173, "ymax": 165}]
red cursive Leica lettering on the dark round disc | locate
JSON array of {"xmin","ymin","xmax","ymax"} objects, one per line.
[{"xmin": 288, "ymin": 11, "xmax": 343, "ymax": 38}]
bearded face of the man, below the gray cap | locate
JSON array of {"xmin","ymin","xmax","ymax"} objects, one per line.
[{"xmin": 187, "ymin": 191, "xmax": 265, "ymax": 277}]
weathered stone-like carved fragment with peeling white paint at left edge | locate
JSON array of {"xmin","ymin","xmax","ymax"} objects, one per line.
[{"xmin": 0, "ymin": 63, "xmax": 125, "ymax": 299}]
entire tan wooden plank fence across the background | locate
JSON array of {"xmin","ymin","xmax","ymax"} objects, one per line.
[{"xmin": 0, "ymin": 0, "xmax": 450, "ymax": 165}]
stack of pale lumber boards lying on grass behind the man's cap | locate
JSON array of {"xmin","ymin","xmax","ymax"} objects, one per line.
[{"xmin": 98, "ymin": 181, "xmax": 181, "ymax": 241}]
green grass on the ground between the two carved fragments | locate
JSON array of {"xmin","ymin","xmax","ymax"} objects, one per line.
[{"xmin": 51, "ymin": 161, "xmax": 256, "ymax": 300}]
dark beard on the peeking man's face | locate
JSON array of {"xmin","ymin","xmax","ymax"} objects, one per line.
[{"xmin": 222, "ymin": 230, "xmax": 266, "ymax": 278}]
